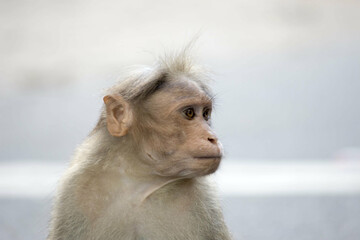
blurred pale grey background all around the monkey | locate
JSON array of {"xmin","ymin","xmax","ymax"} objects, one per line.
[{"xmin": 0, "ymin": 0, "xmax": 360, "ymax": 240}]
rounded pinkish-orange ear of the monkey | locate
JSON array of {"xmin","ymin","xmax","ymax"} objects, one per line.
[{"xmin": 103, "ymin": 95, "xmax": 132, "ymax": 137}]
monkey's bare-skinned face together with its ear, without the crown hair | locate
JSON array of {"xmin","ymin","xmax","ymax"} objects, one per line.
[{"xmin": 104, "ymin": 76, "xmax": 222, "ymax": 178}]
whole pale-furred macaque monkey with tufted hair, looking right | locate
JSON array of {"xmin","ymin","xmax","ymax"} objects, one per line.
[{"xmin": 48, "ymin": 53, "xmax": 231, "ymax": 240}]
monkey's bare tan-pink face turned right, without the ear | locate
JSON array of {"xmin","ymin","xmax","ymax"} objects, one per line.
[{"xmin": 136, "ymin": 81, "xmax": 222, "ymax": 177}]
